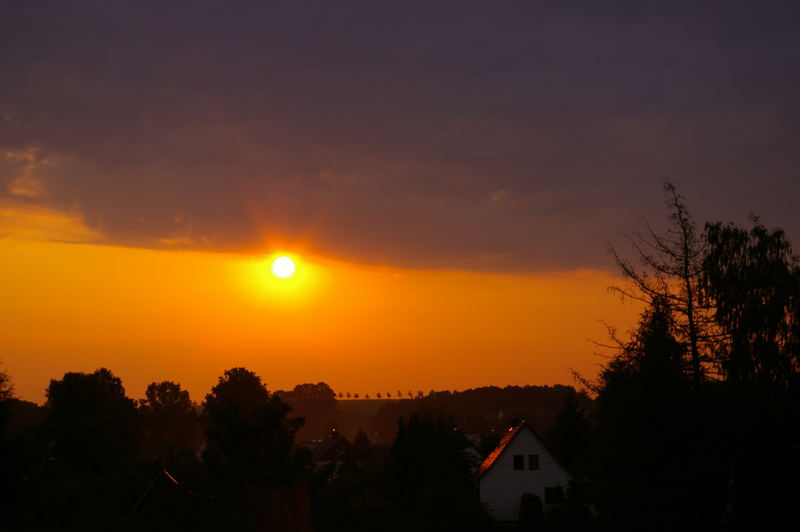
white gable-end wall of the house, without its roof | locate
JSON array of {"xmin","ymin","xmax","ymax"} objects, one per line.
[{"xmin": 479, "ymin": 428, "xmax": 569, "ymax": 521}]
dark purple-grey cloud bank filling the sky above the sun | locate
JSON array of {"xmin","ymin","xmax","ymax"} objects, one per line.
[{"xmin": 0, "ymin": 1, "xmax": 800, "ymax": 270}]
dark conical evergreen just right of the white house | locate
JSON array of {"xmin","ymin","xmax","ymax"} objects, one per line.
[{"xmin": 597, "ymin": 297, "xmax": 723, "ymax": 529}]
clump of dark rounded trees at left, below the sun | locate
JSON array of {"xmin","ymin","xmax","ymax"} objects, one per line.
[{"xmin": 2, "ymin": 368, "xmax": 309, "ymax": 530}]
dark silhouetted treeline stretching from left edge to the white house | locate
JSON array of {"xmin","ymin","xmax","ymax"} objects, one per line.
[{"xmin": 0, "ymin": 368, "xmax": 500, "ymax": 531}]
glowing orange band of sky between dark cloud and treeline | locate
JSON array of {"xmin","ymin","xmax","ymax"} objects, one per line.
[{"xmin": 0, "ymin": 203, "xmax": 636, "ymax": 401}]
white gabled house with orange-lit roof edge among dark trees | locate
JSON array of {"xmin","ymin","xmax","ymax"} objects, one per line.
[{"xmin": 477, "ymin": 421, "xmax": 570, "ymax": 521}]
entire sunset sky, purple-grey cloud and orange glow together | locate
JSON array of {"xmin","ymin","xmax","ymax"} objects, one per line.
[{"xmin": 0, "ymin": 0, "xmax": 800, "ymax": 401}]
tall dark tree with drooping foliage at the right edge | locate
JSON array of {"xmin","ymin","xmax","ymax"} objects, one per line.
[{"xmin": 703, "ymin": 218, "xmax": 800, "ymax": 528}]
